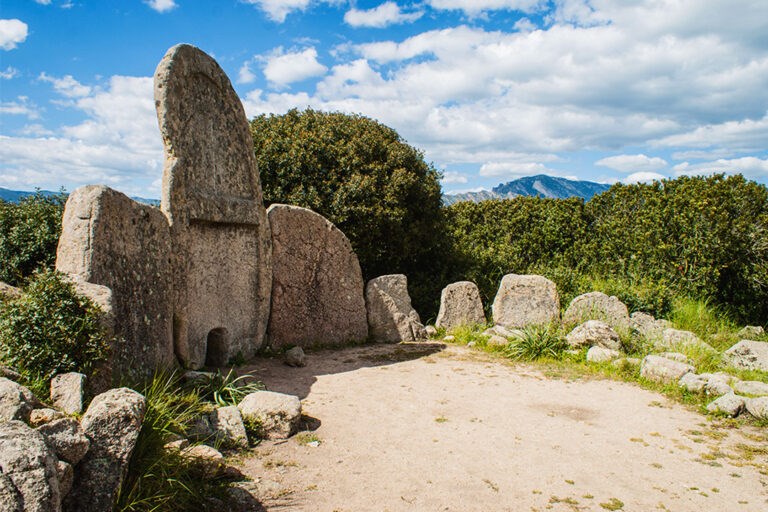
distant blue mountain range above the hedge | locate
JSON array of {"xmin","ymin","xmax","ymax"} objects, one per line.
[{"xmin": 443, "ymin": 174, "xmax": 610, "ymax": 205}]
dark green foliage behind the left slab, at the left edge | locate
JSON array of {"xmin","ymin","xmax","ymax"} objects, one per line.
[{"xmin": 0, "ymin": 192, "xmax": 67, "ymax": 286}]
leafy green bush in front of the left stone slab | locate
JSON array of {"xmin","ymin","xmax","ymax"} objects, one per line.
[{"xmin": 0, "ymin": 270, "xmax": 108, "ymax": 379}]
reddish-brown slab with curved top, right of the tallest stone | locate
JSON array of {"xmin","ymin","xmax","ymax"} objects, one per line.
[{"xmin": 267, "ymin": 204, "xmax": 368, "ymax": 347}]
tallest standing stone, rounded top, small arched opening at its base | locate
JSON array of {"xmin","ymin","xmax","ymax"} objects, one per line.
[{"xmin": 155, "ymin": 45, "xmax": 272, "ymax": 368}]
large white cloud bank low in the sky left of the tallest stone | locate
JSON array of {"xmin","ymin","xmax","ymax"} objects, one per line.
[{"xmin": 0, "ymin": 76, "xmax": 163, "ymax": 197}]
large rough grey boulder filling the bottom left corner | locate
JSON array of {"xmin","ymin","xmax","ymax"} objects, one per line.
[{"xmin": 0, "ymin": 420, "xmax": 61, "ymax": 512}]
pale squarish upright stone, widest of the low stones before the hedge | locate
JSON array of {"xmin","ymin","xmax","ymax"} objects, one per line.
[{"xmin": 492, "ymin": 274, "xmax": 560, "ymax": 329}]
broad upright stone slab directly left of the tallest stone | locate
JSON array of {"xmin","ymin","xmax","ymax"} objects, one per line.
[{"xmin": 56, "ymin": 185, "xmax": 175, "ymax": 376}]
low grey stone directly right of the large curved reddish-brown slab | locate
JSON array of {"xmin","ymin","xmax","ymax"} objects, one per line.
[{"xmin": 365, "ymin": 274, "xmax": 426, "ymax": 343}]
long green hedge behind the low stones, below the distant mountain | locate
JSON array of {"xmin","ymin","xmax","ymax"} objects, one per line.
[{"xmin": 446, "ymin": 175, "xmax": 768, "ymax": 324}]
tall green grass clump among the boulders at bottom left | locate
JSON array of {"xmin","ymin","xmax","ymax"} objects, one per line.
[{"xmin": 116, "ymin": 372, "xmax": 229, "ymax": 512}]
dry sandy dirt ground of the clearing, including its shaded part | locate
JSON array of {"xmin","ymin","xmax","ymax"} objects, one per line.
[{"xmin": 237, "ymin": 343, "xmax": 768, "ymax": 512}]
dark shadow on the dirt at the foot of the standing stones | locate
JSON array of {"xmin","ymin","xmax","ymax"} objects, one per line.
[{"xmin": 237, "ymin": 342, "xmax": 446, "ymax": 398}]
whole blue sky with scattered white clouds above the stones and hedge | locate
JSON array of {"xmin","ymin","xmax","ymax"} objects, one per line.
[{"xmin": 0, "ymin": 0, "xmax": 768, "ymax": 197}]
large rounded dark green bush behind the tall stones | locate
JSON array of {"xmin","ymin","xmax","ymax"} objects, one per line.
[{"xmin": 251, "ymin": 109, "xmax": 448, "ymax": 316}]
